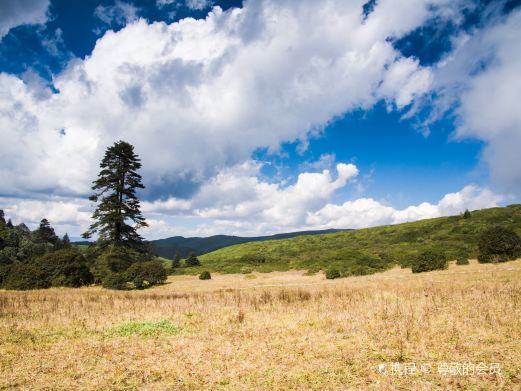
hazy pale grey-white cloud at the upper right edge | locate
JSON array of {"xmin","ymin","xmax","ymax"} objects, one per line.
[{"xmin": 429, "ymin": 10, "xmax": 521, "ymax": 192}]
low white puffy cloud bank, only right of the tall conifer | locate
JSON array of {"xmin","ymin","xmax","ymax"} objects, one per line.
[{"xmin": 143, "ymin": 161, "xmax": 505, "ymax": 235}]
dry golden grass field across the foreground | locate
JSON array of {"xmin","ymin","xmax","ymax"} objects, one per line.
[{"xmin": 0, "ymin": 261, "xmax": 521, "ymax": 390}]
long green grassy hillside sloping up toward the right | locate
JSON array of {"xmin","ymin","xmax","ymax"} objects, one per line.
[{"xmin": 190, "ymin": 205, "xmax": 521, "ymax": 276}]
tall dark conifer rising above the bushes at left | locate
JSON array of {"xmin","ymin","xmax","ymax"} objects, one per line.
[{"xmin": 83, "ymin": 141, "xmax": 148, "ymax": 249}]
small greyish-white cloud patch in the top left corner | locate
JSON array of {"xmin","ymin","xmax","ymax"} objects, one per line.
[{"xmin": 0, "ymin": 0, "xmax": 49, "ymax": 41}]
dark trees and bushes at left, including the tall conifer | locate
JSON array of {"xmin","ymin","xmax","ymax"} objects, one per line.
[{"xmin": 0, "ymin": 141, "xmax": 171, "ymax": 289}]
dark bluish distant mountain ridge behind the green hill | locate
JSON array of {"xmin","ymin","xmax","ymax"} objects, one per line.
[{"xmin": 150, "ymin": 229, "xmax": 345, "ymax": 259}]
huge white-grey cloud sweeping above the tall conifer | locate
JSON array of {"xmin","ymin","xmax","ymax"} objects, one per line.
[{"xmin": 0, "ymin": 0, "xmax": 445, "ymax": 199}]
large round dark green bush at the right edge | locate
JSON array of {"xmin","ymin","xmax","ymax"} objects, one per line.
[{"xmin": 478, "ymin": 226, "xmax": 521, "ymax": 263}]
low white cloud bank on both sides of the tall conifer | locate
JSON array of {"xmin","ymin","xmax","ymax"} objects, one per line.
[{"xmin": 0, "ymin": 161, "xmax": 505, "ymax": 240}]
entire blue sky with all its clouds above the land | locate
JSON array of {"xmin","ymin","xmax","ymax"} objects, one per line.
[{"xmin": 0, "ymin": 0, "xmax": 521, "ymax": 239}]
